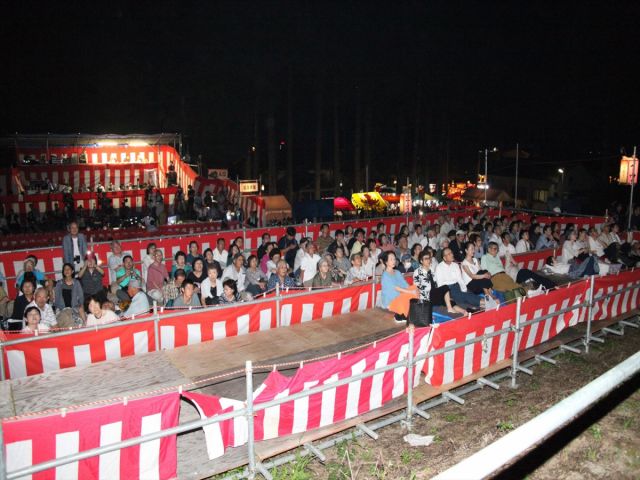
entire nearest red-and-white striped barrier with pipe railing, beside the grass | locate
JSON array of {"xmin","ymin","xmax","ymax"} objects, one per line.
[{"xmin": 2, "ymin": 270, "xmax": 640, "ymax": 478}]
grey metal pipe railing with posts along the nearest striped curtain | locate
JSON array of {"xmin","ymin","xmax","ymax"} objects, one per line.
[{"xmin": 0, "ymin": 276, "xmax": 638, "ymax": 480}]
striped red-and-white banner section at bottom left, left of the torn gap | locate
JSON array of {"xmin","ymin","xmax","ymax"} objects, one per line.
[{"xmin": 2, "ymin": 392, "xmax": 180, "ymax": 480}]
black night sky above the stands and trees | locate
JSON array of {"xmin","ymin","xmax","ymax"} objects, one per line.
[{"xmin": 0, "ymin": 0, "xmax": 640, "ymax": 192}]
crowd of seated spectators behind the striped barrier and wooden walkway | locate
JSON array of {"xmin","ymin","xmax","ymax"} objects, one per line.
[{"xmin": 0, "ymin": 214, "xmax": 640, "ymax": 331}]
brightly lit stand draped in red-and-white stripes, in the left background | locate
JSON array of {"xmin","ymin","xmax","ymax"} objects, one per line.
[{"xmin": 0, "ymin": 134, "xmax": 262, "ymax": 228}]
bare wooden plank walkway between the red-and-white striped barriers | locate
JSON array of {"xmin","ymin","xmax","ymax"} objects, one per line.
[{"xmin": 0, "ymin": 308, "xmax": 404, "ymax": 478}]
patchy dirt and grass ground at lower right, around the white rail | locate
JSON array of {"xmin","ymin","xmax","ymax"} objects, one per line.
[{"xmin": 272, "ymin": 328, "xmax": 640, "ymax": 480}]
